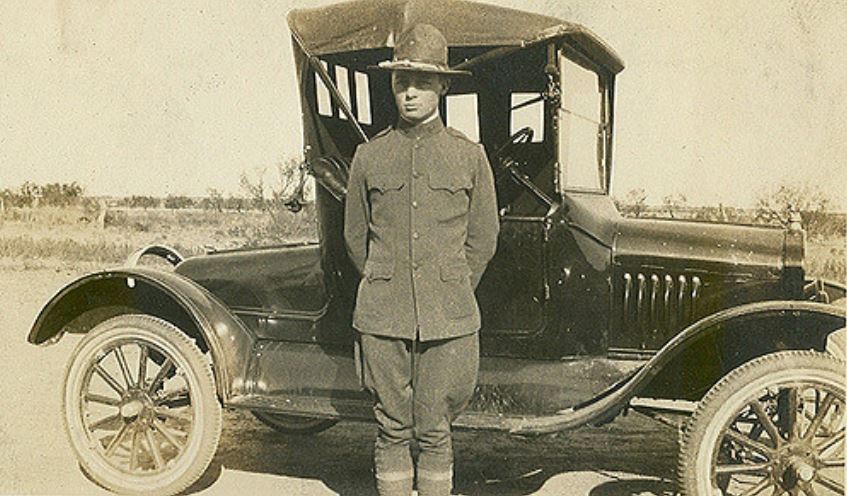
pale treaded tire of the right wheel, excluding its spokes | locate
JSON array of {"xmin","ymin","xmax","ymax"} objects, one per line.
[{"xmin": 679, "ymin": 351, "xmax": 845, "ymax": 496}]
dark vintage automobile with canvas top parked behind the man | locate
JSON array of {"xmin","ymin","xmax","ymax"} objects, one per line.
[{"xmin": 28, "ymin": 0, "xmax": 845, "ymax": 495}]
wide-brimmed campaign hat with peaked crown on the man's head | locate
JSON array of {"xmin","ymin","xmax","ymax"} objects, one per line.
[{"xmin": 377, "ymin": 24, "xmax": 470, "ymax": 76}]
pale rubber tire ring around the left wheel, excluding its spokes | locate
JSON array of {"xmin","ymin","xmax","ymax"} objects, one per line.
[{"xmin": 62, "ymin": 315, "xmax": 222, "ymax": 495}]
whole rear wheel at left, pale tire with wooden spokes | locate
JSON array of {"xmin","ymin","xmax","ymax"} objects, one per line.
[{"xmin": 63, "ymin": 315, "xmax": 222, "ymax": 494}]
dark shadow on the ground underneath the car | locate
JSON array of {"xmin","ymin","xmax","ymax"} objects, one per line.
[{"xmin": 195, "ymin": 412, "xmax": 677, "ymax": 496}]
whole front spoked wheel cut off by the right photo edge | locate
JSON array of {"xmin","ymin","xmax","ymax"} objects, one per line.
[{"xmin": 679, "ymin": 351, "xmax": 845, "ymax": 496}]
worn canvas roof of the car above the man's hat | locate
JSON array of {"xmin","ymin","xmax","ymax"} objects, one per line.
[{"xmin": 288, "ymin": 0, "xmax": 624, "ymax": 73}]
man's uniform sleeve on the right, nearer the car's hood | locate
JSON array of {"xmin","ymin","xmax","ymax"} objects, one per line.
[{"xmin": 465, "ymin": 146, "xmax": 500, "ymax": 288}]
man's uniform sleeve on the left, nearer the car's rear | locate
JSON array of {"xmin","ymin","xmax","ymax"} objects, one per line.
[{"xmin": 344, "ymin": 150, "xmax": 370, "ymax": 274}]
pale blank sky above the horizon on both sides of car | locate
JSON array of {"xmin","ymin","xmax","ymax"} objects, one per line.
[{"xmin": 0, "ymin": 0, "xmax": 847, "ymax": 205}]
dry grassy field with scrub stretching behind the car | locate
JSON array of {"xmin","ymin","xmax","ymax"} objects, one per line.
[{"xmin": 0, "ymin": 207, "xmax": 847, "ymax": 282}]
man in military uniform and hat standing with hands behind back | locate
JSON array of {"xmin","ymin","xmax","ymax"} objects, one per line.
[{"xmin": 344, "ymin": 24, "xmax": 499, "ymax": 496}]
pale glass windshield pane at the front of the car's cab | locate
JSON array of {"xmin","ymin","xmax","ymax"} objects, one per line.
[{"xmin": 558, "ymin": 54, "xmax": 609, "ymax": 193}]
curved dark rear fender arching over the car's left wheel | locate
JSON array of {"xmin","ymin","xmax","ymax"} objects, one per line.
[{"xmin": 27, "ymin": 267, "xmax": 255, "ymax": 399}]
